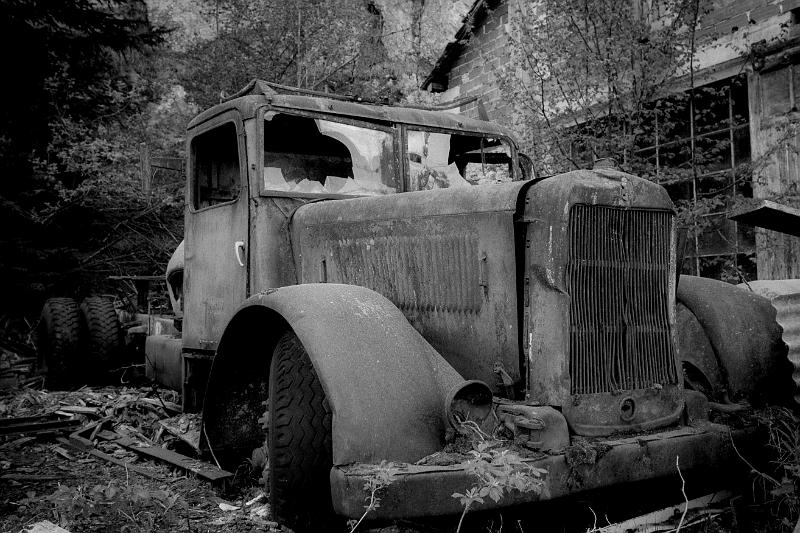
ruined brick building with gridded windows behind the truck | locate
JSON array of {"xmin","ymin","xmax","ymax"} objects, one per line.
[{"xmin": 423, "ymin": 0, "xmax": 800, "ymax": 281}]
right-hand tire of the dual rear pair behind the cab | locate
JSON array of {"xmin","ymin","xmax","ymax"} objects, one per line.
[{"xmin": 80, "ymin": 296, "xmax": 122, "ymax": 377}]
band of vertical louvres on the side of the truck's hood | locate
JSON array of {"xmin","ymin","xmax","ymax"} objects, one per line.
[{"xmin": 326, "ymin": 233, "xmax": 483, "ymax": 312}]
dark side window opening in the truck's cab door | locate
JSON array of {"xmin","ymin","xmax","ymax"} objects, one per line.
[{"xmin": 191, "ymin": 122, "xmax": 241, "ymax": 209}]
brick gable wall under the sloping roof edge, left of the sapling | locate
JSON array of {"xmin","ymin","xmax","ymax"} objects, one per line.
[{"xmin": 448, "ymin": 2, "xmax": 510, "ymax": 121}]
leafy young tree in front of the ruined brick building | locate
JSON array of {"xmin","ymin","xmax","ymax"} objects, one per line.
[{"xmin": 501, "ymin": 0, "xmax": 696, "ymax": 170}]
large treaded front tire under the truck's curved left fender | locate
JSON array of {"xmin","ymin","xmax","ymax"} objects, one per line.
[{"xmin": 265, "ymin": 331, "xmax": 339, "ymax": 532}]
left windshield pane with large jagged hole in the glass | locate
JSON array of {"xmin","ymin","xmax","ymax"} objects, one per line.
[{"xmin": 263, "ymin": 114, "xmax": 399, "ymax": 196}]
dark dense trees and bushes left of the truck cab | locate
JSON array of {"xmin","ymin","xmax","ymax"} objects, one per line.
[{"xmin": 0, "ymin": 0, "xmax": 187, "ymax": 316}]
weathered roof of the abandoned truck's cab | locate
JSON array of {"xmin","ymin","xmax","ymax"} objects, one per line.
[{"xmin": 187, "ymin": 80, "xmax": 514, "ymax": 139}]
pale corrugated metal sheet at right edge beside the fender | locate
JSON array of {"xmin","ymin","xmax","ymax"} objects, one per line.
[{"xmin": 739, "ymin": 279, "xmax": 800, "ymax": 403}]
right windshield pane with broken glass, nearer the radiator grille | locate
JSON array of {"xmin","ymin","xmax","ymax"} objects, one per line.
[{"xmin": 406, "ymin": 129, "xmax": 513, "ymax": 191}]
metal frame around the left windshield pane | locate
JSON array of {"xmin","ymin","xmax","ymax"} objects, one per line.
[{"xmin": 256, "ymin": 105, "xmax": 406, "ymax": 199}]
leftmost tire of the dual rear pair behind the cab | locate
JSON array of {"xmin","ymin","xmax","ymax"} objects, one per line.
[{"xmin": 36, "ymin": 298, "xmax": 81, "ymax": 388}]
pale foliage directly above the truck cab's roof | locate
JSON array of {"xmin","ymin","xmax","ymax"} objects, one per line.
[{"xmin": 179, "ymin": 0, "xmax": 396, "ymax": 107}]
